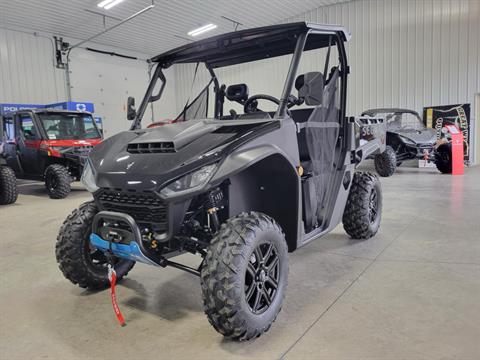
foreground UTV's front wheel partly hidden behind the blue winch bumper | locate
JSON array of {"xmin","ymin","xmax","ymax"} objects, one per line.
[{"xmin": 55, "ymin": 201, "xmax": 135, "ymax": 289}]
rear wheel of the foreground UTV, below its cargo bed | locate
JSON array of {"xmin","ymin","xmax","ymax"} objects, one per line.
[{"xmin": 342, "ymin": 172, "xmax": 382, "ymax": 239}]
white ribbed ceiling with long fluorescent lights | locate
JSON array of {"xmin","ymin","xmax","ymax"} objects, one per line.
[{"xmin": 0, "ymin": 0, "xmax": 349, "ymax": 56}]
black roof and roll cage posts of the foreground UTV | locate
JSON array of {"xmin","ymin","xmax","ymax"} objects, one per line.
[{"xmin": 131, "ymin": 22, "xmax": 351, "ymax": 130}]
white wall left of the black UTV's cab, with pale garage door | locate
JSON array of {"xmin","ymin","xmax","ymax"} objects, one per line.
[{"xmin": 0, "ymin": 28, "xmax": 176, "ymax": 136}]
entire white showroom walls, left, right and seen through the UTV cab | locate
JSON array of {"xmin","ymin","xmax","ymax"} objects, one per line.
[{"xmin": 0, "ymin": 0, "xmax": 480, "ymax": 135}]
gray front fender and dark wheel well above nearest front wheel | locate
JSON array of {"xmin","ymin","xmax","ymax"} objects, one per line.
[{"xmin": 211, "ymin": 144, "xmax": 301, "ymax": 251}]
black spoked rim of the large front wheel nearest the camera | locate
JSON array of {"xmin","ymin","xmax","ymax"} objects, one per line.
[{"xmin": 245, "ymin": 243, "xmax": 280, "ymax": 315}]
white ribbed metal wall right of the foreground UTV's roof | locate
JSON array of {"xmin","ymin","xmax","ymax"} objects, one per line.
[{"xmin": 288, "ymin": 0, "xmax": 480, "ymax": 114}]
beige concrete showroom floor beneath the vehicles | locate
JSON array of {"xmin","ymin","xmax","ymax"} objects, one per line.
[{"xmin": 0, "ymin": 167, "xmax": 480, "ymax": 360}]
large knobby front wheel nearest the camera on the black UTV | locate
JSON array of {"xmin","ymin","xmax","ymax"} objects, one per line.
[{"xmin": 201, "ymin": 212, "xmax": 288, "ymax": 341}]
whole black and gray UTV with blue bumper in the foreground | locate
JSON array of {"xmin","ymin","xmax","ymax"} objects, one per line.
[{"xmin": 56, "ymin": 22, "xmax": 386, "ymax": 340}]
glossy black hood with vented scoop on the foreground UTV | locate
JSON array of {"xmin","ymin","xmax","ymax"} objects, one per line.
[{"xmin": 90, "ymin": 119, "xmax": 279, "ymax": 190}]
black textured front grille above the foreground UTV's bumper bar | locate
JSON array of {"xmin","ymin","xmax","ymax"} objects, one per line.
[{"xmin": 96, "ymin": 189, "xmax": 168, "ymax": 231}]
